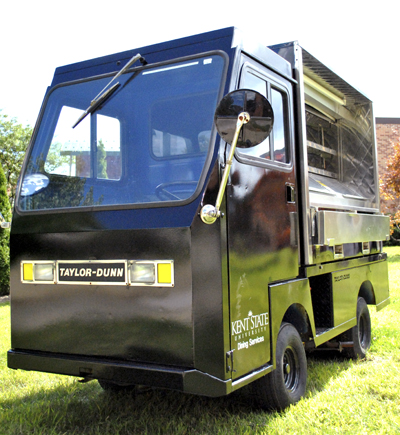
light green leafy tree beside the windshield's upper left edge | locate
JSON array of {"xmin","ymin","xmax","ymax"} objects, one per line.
[{"xmin": 0, "ymin": 113, "xmax": 32, "ymax": 204}]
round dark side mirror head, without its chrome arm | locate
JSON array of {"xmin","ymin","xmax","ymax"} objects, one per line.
[{"xmin": 214, "ymin": 89, "xmax": 274, "ymax": 148}]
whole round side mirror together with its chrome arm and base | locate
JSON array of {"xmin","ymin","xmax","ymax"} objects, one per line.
[{"xmin": 200, "ymin": 89, "xmax": 274, "ymax": 224}]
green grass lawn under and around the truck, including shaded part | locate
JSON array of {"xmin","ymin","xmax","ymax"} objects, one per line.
[{"xmin": 0, "ymin": 247, "xmax": 400, "ymax": 435}]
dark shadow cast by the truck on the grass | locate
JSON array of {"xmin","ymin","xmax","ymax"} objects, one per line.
[{"xmin": 0, "ymin": 354, "xmax": 351, "ymax": 435}]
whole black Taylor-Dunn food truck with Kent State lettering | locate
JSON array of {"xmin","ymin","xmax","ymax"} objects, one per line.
[{"xmin": 8, "ymin": 28, "xmax": 389, "ymax": 409}]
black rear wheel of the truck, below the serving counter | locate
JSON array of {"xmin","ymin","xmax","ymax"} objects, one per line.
[{"xmin": 343, "ymin": 297, "xmax": 371, "ymax": 359}]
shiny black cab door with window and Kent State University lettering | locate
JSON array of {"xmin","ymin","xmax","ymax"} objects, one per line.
[{"xmin": 226, "ymin": 60, "xmax": 298, "ymax": 378}]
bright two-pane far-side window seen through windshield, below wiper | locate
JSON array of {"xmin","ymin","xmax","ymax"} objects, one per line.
[{"xmin": 44, "ymin": 106, "xmax": 122, "ymax": 180}]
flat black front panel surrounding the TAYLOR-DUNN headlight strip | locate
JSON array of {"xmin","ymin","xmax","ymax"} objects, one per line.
[{"xmin": 12, "ymin": 228, "xmax": 193, "ymax": 366}]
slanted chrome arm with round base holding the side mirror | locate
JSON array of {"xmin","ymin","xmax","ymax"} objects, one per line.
[{"xmin": 200, "ymin": 112, "xmax": 250, "ymax": 225}]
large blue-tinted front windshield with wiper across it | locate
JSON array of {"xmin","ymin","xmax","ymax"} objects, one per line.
[{"xmin": 18, "ymin": 54, "xmax": 224, "ymax": 211}]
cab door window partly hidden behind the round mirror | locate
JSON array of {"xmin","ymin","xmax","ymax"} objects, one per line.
[{"xmin": 238, "ymin": 69, "xmax": 290, "ymax": 163}]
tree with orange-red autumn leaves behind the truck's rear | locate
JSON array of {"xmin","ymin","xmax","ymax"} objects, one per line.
[{"xmin": 380, "ymin": 143, "xmax": 400, "ymax": 237}]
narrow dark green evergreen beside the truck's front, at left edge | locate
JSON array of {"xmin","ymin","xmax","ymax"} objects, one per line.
[{"xmin": 0, "ymin": 166, "xmax": 11, "ymax": 296}]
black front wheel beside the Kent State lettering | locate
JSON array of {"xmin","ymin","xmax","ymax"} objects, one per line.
[{"xmin": 253, "ymin": 323, "xmax": 307, "ymax": 410}]
